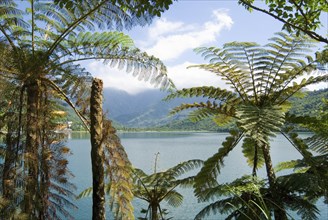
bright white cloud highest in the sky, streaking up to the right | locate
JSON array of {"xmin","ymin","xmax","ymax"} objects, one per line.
[{"xmin": 146, "ymin": 9, "xmax": 233, "ymax": 61}]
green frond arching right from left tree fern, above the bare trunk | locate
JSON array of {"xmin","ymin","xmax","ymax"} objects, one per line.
[{"xmin": 54, "ymin": 32, "xmax": 174, "ymax": 89}]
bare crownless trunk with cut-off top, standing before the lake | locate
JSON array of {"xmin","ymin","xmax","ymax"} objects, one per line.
[{"xmin": 90, "ymin": 79, "xmax": 105, "ymax": 220}]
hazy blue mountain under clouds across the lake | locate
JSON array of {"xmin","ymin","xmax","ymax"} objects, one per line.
[{"xmin": 103, "ymin": 88, "xmax": 202, "ymax": 128}]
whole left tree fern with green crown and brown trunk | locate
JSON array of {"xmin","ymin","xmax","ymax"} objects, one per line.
[{"xmin": 0, "ymin": 0, "xmax": 172, "ymax": 219}]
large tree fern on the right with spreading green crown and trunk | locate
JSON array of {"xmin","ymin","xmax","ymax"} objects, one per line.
[{"xmin": 168, "ymin": 33, "xmax": 328, "ymax": 219}]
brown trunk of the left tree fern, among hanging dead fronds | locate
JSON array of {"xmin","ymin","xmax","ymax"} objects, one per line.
[{"xmin": 24, "ymin": 80, "xmax": 41, "ymax": 218}]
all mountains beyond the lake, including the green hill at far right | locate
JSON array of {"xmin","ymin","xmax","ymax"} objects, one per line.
[{"xmin": 104, "ymin": 88, "xmax": 328, "ymax": 131}]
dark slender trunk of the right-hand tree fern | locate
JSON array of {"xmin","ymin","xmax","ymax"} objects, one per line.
[{"xmin": 262, "ymin": 144, "xmax": 287, "ymax": 220}]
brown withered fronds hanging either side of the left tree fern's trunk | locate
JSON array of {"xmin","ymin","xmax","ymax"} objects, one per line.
[{"xmin": 0, "ymin": 86, "xmax": 77, "ymax": 219}]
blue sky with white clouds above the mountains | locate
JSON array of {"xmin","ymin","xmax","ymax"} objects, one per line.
[{"xmin": 86, "ymin": 0, "xmax": 328, "ymax": 94}]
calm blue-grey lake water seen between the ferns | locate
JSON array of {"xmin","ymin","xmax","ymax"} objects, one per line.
[{"xmin": 68, "ymin": 132, "xmax": 328, "ymax": 220}]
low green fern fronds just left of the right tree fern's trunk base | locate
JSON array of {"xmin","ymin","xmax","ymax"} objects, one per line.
[{"xmin": 195, "ymin": 176, "xmax": 271, "ymax": 219}]
